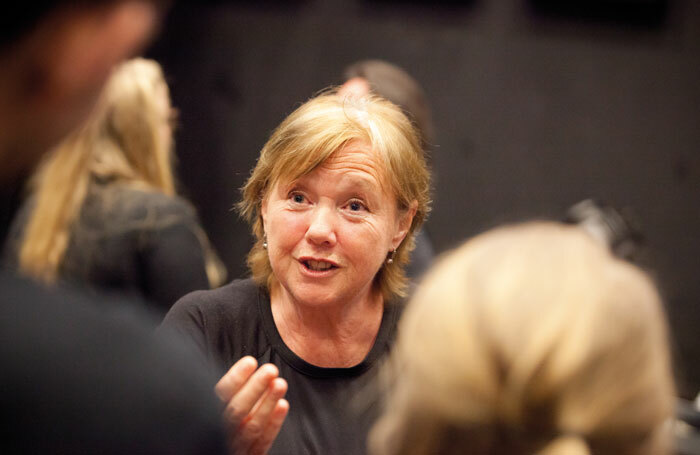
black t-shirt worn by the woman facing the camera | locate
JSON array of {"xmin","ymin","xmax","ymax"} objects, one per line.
[{"xmin": 162, "ymin": 280, "xmax": 401, "ymax": 455}]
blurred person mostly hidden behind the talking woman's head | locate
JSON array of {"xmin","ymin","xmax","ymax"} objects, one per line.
[{"xmin": 338, "ymin": 60, "xmax": 435, "ymax": 280}]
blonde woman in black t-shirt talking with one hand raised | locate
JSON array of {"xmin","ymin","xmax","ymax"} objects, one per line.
[{"xmin": 163, "ymin": 92, "xmax": 429, "ymax": 455}]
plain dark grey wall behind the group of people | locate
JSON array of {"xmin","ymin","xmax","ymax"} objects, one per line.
[{"xmin": 149, "ymin": 0, "xmax": 700, "ymax": 396}]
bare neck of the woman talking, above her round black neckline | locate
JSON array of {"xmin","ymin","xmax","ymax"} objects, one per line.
[{"xmin": 270, "ymin": 284, "xmax": 384, "ymax": 368}]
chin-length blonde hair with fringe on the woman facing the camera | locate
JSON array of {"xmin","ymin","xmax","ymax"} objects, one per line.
[{"xmin": 238, "ymin": 91, "xmax": 430, "ymax": 300}]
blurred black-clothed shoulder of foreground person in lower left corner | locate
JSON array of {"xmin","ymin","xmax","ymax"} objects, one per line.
[{"xmin": 0, "ymin": 272, "xmax": 225, "ymax": 455}]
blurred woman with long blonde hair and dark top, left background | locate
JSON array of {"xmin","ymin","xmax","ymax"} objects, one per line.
[{"xmin": 6, "ymin": 58, "xmax": 223, "ymax": 312}]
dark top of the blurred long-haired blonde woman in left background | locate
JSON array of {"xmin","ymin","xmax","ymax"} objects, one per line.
[{"xmin": 5, "ymin": 181, "xmax": 209, "ymax": 314}]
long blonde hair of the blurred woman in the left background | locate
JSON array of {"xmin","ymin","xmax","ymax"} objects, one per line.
[{"xmin": 19, "ymin": 58, "xmax": 175, "ymax": 282}]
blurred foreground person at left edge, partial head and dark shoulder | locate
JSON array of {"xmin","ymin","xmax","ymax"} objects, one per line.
[{"xmin": 0, "ymin": 0, "xmax": 224, "ymax": 455}]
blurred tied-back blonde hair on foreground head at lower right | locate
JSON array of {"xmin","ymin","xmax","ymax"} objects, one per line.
[{"xmin": 369, "ymin": 223, "xmax": 674, "ymax": 455}]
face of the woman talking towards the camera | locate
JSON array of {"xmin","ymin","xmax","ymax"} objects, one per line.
[{"xmin": 262, "ymin": 141, "xmax": 413, "ymax": 306}]
